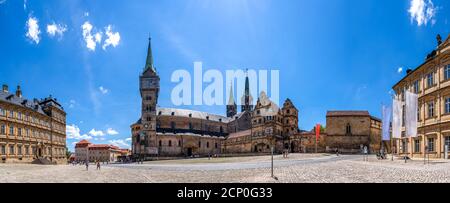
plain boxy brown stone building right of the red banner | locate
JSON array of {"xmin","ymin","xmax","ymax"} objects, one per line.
[{"xmin": 324, "ymin": 111, "xmax": 381, "ymax": 153}]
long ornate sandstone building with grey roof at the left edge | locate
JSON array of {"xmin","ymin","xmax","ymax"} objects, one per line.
[{"xmin": 0, "ymin": 85, "xmax": 67, "ymax": 164}]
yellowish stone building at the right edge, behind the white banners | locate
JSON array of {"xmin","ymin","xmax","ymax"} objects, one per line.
[{"xmin": 393, "ymin": 35, "xmax": 450, "ymax": 158}]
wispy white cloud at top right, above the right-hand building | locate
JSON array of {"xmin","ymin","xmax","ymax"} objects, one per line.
[{"xmin": 408, "ymin": 0, "xmax": 437, "ymax": 26}]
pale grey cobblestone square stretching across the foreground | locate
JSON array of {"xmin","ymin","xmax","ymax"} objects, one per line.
[{"xmin": 0, "ymin": 154, "xmax": 450, "ymax": 183}]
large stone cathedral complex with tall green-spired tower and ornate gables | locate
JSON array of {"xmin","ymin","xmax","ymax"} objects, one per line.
[{"xmin": 131, "ymin": 38, "xmax": 300, "ymax": 159}]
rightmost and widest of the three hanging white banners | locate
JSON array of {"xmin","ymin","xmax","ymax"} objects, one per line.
[{"xmin": 405, "ymin": 91, "xmax": 419, "ymax": 137}]
